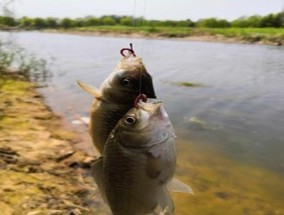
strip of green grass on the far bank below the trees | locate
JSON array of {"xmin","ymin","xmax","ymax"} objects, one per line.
[{"xmin": 61, "ymin": 25, "xmax": 284, "ymax": 45}]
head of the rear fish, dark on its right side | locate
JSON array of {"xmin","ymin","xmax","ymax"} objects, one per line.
[{"xmin": 101, "ymin": 57, "xmax": 156, "ymax": 104}]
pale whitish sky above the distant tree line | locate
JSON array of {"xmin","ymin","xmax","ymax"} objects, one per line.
[{"xmin": 3, "ymin": 0, "xmax": 284, "ymax": 21}]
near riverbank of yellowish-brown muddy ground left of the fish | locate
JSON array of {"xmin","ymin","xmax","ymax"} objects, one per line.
[{"xmin": 0, "ymin": 73, "xmax": 105, "ymax": 215}]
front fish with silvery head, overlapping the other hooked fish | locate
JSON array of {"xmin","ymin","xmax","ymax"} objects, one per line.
[{"xmin": 91, "ymin": 100, "xmax": 176, "ymax": 215}]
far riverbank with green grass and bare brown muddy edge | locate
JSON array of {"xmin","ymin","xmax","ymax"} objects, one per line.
[{"xmin": 43, "ymin": 26, "xmax": 284, "ymax": 46}]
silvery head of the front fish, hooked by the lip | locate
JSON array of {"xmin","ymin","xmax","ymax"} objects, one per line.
[{"xmin": 111, "ymin": 101, "xmax": 175, "ymax": 151}]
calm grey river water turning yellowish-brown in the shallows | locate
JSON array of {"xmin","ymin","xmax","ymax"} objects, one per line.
[{"xmin": 0, "ymin": 32, "xmax": 284, "ymax": 214}]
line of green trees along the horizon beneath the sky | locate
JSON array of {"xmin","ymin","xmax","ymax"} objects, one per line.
[{"xmin": 0, "ymin": 12, "xmax": 284, "ymax": 29}]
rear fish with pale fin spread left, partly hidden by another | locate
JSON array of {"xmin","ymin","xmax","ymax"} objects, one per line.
[{"xmin": 77, "ymin": 55, "xmax": 156, "ymax": 154}]
